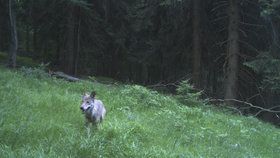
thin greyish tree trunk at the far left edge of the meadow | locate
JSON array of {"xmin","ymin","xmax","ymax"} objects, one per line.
[{"xmin": 8, "ymin": 0, "xmax": 18, "ymax": 68}]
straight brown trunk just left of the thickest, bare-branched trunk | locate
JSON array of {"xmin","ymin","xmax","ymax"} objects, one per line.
[{"xmin": 192, "ymin": 0, "xmax": 201, "ymax": 88}]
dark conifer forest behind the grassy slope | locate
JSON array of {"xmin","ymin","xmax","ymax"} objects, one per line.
[{"xmin": 0, "ymin": 0, "xmax": 280, "ymax": 125}]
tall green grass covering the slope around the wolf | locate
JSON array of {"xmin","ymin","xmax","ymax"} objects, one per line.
[{"xmin": 0, "ymin": 67, "xmax": 280, "ymax": 158}]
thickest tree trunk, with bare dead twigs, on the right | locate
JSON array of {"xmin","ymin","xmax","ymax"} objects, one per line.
[{"xmin": 225, "ymin": 0, "xmax": 239, "ymax": 104}]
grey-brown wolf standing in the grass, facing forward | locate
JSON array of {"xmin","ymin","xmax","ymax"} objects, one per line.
[{"xmin": 80, "ymin": 92, "xmax": 106, "ymax": 126}]
